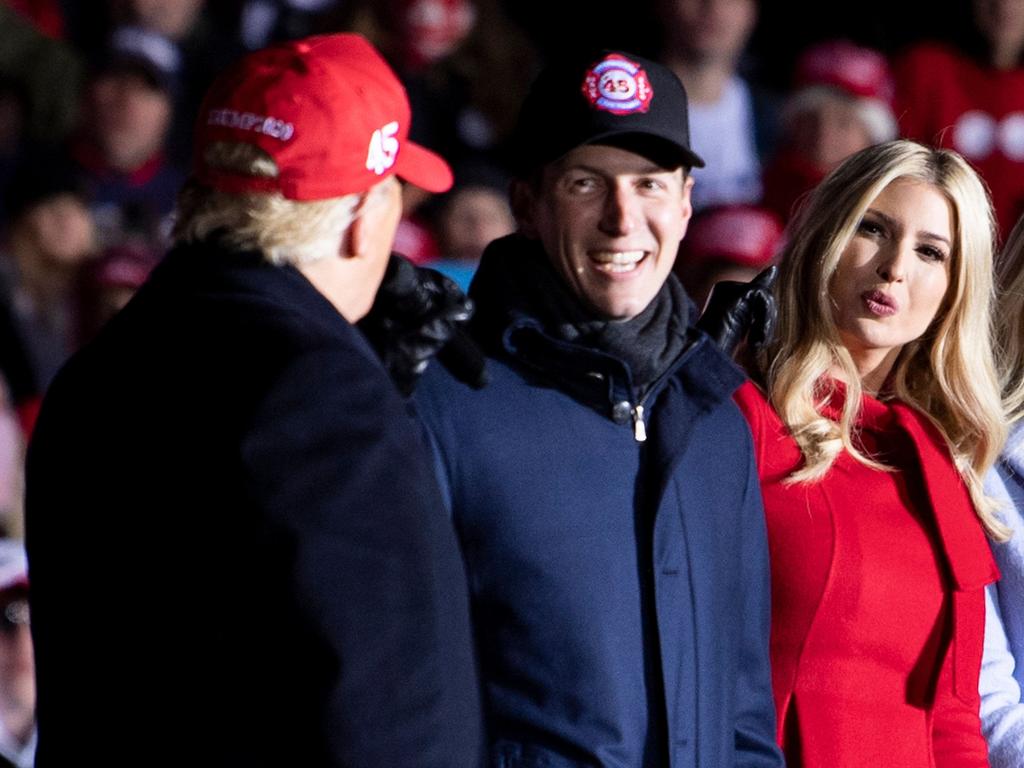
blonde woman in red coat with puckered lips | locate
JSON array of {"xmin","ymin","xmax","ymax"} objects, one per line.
[{"xmin": 737, "ymin": 141, "xmax": 1005, "ymax": 768}]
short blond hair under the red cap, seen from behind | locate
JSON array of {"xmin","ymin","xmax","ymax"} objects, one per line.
[{"xmin": 172, "ymin": 142, "xmax": 364, "ymax": 265}]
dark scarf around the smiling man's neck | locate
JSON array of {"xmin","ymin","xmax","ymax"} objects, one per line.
[{"xmin": 470, "ymin": 234, "xmax": 695, "ymax": 396}]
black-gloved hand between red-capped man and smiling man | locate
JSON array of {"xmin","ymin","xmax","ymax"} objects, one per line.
[{"xmin": 358, "ymin": 253, "xmax": 486, "ymax": 397}]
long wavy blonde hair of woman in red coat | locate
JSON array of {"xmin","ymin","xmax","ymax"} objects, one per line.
[{"xmin": 762, "ymin": 140, "xmax": 1007, "ymax": 539}]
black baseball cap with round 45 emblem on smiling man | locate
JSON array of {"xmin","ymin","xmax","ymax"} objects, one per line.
[{"xmin": 512, "ymin": 49, "xmax": 705, "ymax": 175}]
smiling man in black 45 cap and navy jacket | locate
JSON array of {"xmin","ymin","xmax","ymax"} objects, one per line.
[{"xmin": 417, "ymin": 51, "xmax": 781, "ymax": 768}]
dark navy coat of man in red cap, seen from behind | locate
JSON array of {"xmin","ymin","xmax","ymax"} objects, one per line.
[{"xmin": 27, "ymin": 240, "xmax": 482, "ymax": 768}]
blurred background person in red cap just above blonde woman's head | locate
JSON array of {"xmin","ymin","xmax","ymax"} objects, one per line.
[{"xmin": 764, "ymin": 40, "xmax": 897, "ymax": 221}]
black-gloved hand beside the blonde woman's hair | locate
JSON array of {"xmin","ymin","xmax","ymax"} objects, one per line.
[{"xmin": 697, "ymin": 264, "xmax": 778, "ymax": 355}]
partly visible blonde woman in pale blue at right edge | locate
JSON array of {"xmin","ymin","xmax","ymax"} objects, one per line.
[{"xmin": 981, "ymin": 218, "xmax": 1024, "ymax": 768}]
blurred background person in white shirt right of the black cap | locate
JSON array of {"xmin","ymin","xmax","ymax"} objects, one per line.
[{"xmin": 656, "ymin": 0, "xmax": 775, "ymax": 211}]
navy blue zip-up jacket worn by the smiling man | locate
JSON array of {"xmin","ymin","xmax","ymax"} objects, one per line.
[{"xmin": 416, "ymin": 237, "xmax": 781, "ymax": 768}]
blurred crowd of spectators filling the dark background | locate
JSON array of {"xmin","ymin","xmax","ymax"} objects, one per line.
[{"xmin": 0, "ymin": 0, "xmax": 1024, "ymax": 752}]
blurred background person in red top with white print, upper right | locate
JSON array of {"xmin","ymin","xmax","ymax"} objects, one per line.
[{"xmin": 895, "ymin": 0, "xmax": 1024, "ymax": 239}]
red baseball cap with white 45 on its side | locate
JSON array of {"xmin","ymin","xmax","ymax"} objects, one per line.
[{"xmin": 194, "ymin": 33, "xmax": 452, "ymax": 201}]
